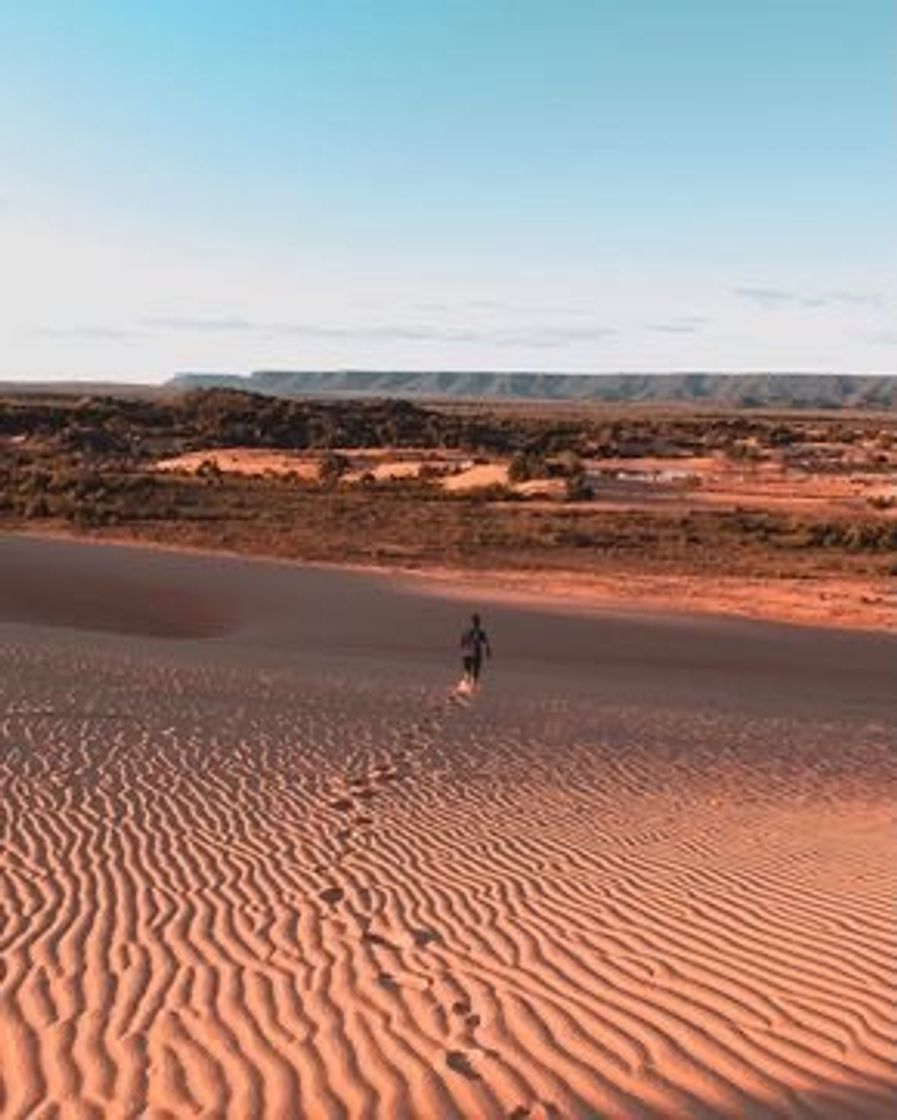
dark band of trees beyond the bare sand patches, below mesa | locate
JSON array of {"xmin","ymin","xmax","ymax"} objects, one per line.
[{"xmin": 0, "ymin": 390, "xmax": 894, "ymax": 463}]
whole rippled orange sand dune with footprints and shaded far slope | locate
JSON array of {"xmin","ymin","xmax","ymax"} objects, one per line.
[{"xmin": 0, "ymin": 538, "xmax": 897, "ymax": 1120}]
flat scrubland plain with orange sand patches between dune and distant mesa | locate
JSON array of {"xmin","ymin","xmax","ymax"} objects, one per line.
[{"xmin": 0, "ymin": 385, "xmax": 897, "ymax": 631}]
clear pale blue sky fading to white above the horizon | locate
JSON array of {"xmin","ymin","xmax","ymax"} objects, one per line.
[{"xmin": 0, "ymin": 0, "xmax": 897, "ymax": 382}]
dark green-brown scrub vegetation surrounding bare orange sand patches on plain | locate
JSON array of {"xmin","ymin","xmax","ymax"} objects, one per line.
[{"xmin": 0, "ymin": 392, "xmax": 897, "ymax": 577}]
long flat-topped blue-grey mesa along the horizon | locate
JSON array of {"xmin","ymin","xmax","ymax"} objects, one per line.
[{"xmin": 167, "ymin": 370, "xmax": 897, "ymax": 409}]
